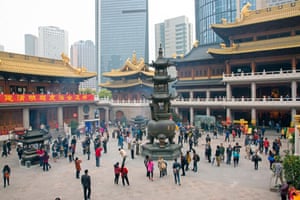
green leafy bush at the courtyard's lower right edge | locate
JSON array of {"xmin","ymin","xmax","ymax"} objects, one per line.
[{"xmin": 283, "ymin": 154, "xmax": 300, "ymax": 189}]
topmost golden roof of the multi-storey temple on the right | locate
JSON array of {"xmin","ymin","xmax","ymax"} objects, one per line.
[{"xmin": 211, "ymin": 2, "xmax": 300, "ymax": 29}]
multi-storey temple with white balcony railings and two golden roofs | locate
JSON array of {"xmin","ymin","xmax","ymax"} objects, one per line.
[{"xmin": 172, "ymin": 2, "xmax": 300, "ymax": 127}]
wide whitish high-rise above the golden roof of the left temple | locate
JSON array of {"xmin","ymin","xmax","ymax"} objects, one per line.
[{"xmin": 38, "ymin": 26, "xmax": 69, "ymax": 59}]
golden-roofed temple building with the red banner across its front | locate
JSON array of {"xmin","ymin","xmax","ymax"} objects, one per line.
[{"xmin": 0, "ymin": 52, "xmax": 96, "ymax": 134}]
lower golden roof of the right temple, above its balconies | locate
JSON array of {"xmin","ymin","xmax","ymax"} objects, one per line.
[{"xmin": 207, "ymin": 35, "xmax": 300, "ymax": 55}]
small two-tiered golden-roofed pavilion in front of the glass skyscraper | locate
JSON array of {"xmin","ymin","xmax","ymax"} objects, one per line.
[{"xmin": 100, "ymin": 52, "xmax": 154, "ymax": 101}]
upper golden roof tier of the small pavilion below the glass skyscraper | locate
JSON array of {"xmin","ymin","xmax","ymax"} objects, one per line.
[{"xmin": 102, "ymin": 52, "xmax": 154, "ymax": 77}]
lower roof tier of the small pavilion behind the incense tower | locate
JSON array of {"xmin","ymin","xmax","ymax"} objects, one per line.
[{"xmin": 99, "ymin": 79, "xmax": 153, "ymax": 88}]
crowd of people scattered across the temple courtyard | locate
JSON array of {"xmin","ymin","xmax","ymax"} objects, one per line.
[{"xmin": 2, "ymin": 121, "xmax": 298, "ymax": 199}]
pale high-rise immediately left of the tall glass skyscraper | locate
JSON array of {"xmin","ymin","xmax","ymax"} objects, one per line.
[{"xmin": 70, "ymin": 40, "xmax": 97, "ymax": 89}]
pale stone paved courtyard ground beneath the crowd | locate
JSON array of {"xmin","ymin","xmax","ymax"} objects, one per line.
[{"xmin": 0, "ymin": 129, "xmax": 286, "ymax": 200}]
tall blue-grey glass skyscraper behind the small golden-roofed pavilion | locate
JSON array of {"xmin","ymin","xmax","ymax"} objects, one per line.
[{"xmin": 95, "ymin": 0, "xmax": 149, "ymax": 83}]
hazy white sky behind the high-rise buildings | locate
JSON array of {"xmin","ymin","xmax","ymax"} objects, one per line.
[{"xmin": 0, "ymin": 0, "xmax": 195, "ymax": 61}]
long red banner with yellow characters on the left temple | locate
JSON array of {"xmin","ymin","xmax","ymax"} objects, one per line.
[{"xmin": 0, "ymin": 94, "xmax": 94, "ymax": 103}]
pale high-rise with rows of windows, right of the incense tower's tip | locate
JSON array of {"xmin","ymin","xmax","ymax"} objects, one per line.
[{"xmin": 155, "ymin": 16, "xmax": 193, "ymax": 57}]
